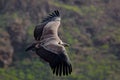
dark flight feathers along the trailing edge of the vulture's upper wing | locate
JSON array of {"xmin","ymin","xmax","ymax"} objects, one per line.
[{"xmin": 34, "ymin": 10, "xmax": 60, "ymax": 41}]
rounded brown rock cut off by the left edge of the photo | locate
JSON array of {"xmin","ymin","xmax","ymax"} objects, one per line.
[{"xmin": 0, "ymin": 29, "xmax": 13, "ymax": 67}]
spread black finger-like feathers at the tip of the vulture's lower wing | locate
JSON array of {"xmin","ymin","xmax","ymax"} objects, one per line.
[{"xmin": 50, "ymin": 57, "xmax": 72, "ymax": 76}]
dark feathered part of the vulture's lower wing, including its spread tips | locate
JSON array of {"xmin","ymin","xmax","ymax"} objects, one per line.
[{"xmin": 36, "ymin": 45, "xmax": 72, "ymax": 76}]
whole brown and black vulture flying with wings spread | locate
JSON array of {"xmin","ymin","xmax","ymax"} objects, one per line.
[{"xmin": 26, "ymin": 10, "xmax": 72, "ymax": 76}]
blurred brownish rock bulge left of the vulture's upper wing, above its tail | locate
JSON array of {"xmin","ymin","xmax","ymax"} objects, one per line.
[{"xmin": 7, "ymin": 22, "xmax": 26, "ymax": 50}]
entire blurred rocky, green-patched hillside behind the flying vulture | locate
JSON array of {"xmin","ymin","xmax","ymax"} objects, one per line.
[{"xmin": 0, "ymin": 0, "xmax": 120, "ymax": 80}]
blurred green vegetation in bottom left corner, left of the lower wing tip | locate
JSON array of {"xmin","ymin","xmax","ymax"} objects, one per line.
[{"xmin": 0, "ymin": 60, "xmax": 52, "ymax": 80}]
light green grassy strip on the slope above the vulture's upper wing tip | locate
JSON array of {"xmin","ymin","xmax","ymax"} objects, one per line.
[{"xmin": 50, "ymin": 1, "xmax": 103, "ymax": 16}]
